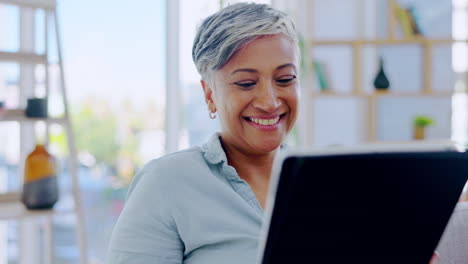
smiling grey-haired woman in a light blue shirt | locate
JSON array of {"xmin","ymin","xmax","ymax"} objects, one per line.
[{"xmin": 109, "ymin": 3, "xmax": 299, "ymax": 264}]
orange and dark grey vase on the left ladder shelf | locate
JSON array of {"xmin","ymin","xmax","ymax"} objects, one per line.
[{"xmin": 21, "ymin": 145, "xmax": 58, "ymax": 209}]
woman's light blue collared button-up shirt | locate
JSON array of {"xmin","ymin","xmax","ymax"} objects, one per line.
[{"xmin": 108, "ymin": 134, "xmax": 263, "ymax": 264}]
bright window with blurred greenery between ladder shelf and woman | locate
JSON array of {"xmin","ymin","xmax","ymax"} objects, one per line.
[{"xmin": 56, "ymin": 0, "xmax": 166, "ymax": 263}]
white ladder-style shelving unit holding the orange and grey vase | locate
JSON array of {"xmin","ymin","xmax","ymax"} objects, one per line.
[{"xmin": 0, "ymin": 0, "xmax": 87, "ymax": 264}]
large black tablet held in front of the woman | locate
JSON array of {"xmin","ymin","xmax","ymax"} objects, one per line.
[{"xmin": 259, "ymin": 144, "xmax": 468, "ymax": 264}]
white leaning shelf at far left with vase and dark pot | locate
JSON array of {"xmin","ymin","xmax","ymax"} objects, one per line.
[{"xmin": 0, "ymin": 0, "xmax": 88, "ymax": 264}]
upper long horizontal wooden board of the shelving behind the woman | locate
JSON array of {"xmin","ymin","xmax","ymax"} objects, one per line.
[{"xmin": 310, "ymin": 37, "xmax": 468, "ymax": 46}]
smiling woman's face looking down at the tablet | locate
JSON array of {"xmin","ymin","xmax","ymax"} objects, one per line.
[{"xmin": 202, "ymin": 35, "xmax": 299, "ymax": 154}]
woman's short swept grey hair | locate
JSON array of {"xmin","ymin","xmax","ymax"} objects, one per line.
[{"xmin": 192, "ymin": 3, "xmax": 299, "ymax": 82}]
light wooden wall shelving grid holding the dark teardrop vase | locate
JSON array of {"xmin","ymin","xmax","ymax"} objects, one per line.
[{"xmin": 306, "ymin": 0, "xmax": 462, "ymax": 144}]
